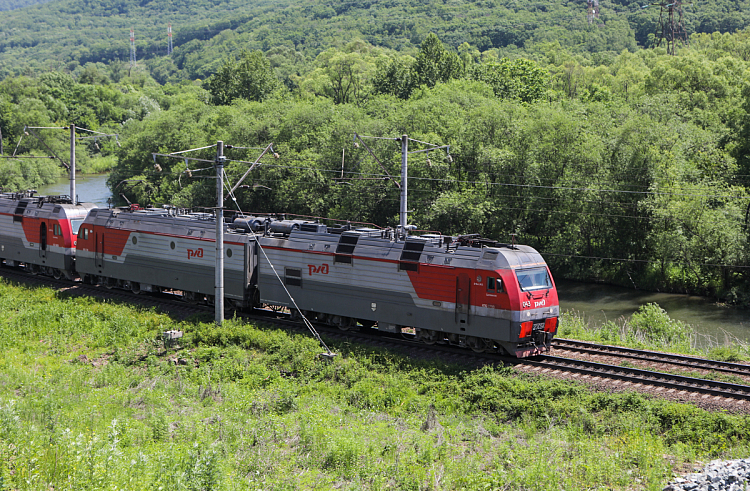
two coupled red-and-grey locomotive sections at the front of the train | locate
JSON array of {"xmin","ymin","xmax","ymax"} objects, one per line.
[{"xmin": 70, "ymin": 205, "xmax": 559, "ymax": 357}]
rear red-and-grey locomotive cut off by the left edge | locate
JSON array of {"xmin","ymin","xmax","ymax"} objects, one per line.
[{"xmin": 0, "ymin": 191, "xmax": 95, "ymax": 279}]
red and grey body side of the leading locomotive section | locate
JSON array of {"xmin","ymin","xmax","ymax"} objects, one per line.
[{"xmin": 258, "ymin": 232, "xmax": 558, "ymax": 345}]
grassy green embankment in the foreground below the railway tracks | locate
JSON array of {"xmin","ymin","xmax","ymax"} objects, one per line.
[{"xmin": 0, "ymin": 281, "xmax": 750, "ymax": 490}]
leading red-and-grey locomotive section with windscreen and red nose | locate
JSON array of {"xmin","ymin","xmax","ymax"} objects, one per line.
[{"xmin": 251, "ymin": 219, "xmax": 559, "ymax": 357}]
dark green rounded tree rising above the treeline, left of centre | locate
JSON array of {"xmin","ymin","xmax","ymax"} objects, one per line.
[{"xmin": 206, "ymin": 50, "xmax": 279, "ymax": 105}]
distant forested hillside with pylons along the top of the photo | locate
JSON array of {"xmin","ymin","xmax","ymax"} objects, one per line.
[{"xmin": 0, "ymin": 0, "xmax": 750, "ymax": 82}]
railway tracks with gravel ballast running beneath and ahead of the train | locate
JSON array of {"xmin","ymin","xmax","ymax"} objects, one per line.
[{"xmin": 0, "ymin": 267, "xmax": 750, "ymax": 410}]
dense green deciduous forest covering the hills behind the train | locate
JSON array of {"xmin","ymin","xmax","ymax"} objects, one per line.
[{"xmin": 0, "ymin": 0, "xmax": 750, "ymax": 305}]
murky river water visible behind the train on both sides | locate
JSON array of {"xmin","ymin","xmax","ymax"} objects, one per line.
[{"xmin": 32, "ymin": 175, "xmax": 750, "ymax": 342}]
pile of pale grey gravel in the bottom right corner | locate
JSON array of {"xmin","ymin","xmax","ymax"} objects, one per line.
[{"xmin": 664, "ymin": 459, "xmax": 750, "ymax": 491}]
